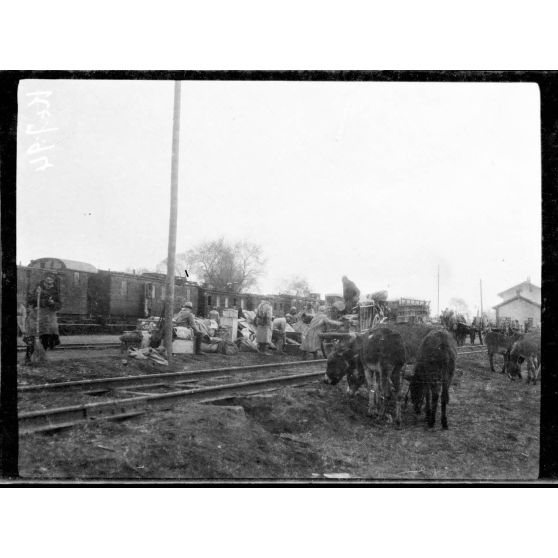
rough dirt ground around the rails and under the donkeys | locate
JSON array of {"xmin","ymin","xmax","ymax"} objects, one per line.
[{"xmin": 20, "ymin": 352, "xmax": 540, "ymax": 480}]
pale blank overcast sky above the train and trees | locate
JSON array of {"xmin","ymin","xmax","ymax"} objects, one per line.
[{"xmin": 17, "ymin": 80, "xmax": 541, "ymax": 313}]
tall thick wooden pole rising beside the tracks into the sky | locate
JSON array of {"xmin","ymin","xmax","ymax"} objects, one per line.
[{"xmin": 165, "ymin": 81, "xmax": 180, "ymax": 362}]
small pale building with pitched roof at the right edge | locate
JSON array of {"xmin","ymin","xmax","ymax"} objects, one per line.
[{"xmin": 494, "ymin": 279, "xmax": 541, "ymax": 327}]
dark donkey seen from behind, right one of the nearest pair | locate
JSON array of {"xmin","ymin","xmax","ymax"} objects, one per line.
[{"xmin": 410, "ymin": 330, "xmax": 457, "ymax": 429}]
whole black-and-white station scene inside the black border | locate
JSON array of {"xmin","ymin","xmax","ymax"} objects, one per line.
[{"xmin": 2, "ymin": 72, "xmax": 544, "ymax": 483}]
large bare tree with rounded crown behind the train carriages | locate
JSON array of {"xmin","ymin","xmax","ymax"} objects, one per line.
[{"xmin": 159, "ymin": 237, "xmax": 265, "ymax": 292}]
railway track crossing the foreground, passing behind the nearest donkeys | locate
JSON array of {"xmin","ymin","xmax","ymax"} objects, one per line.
[{"xmin": 18, "ymin": 345, "xmax": 484, "ymax": 435}]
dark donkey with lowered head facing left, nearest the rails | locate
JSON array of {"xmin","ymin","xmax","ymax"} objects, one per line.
[{"xmin": 324, "ymin": 328, "xmax": 406, "ymax": 427}]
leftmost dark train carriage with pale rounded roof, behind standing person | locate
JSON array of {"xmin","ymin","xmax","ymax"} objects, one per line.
[{"xmin": 25, "ymin": 258, "xmax": 98, "ymax": 323}]
